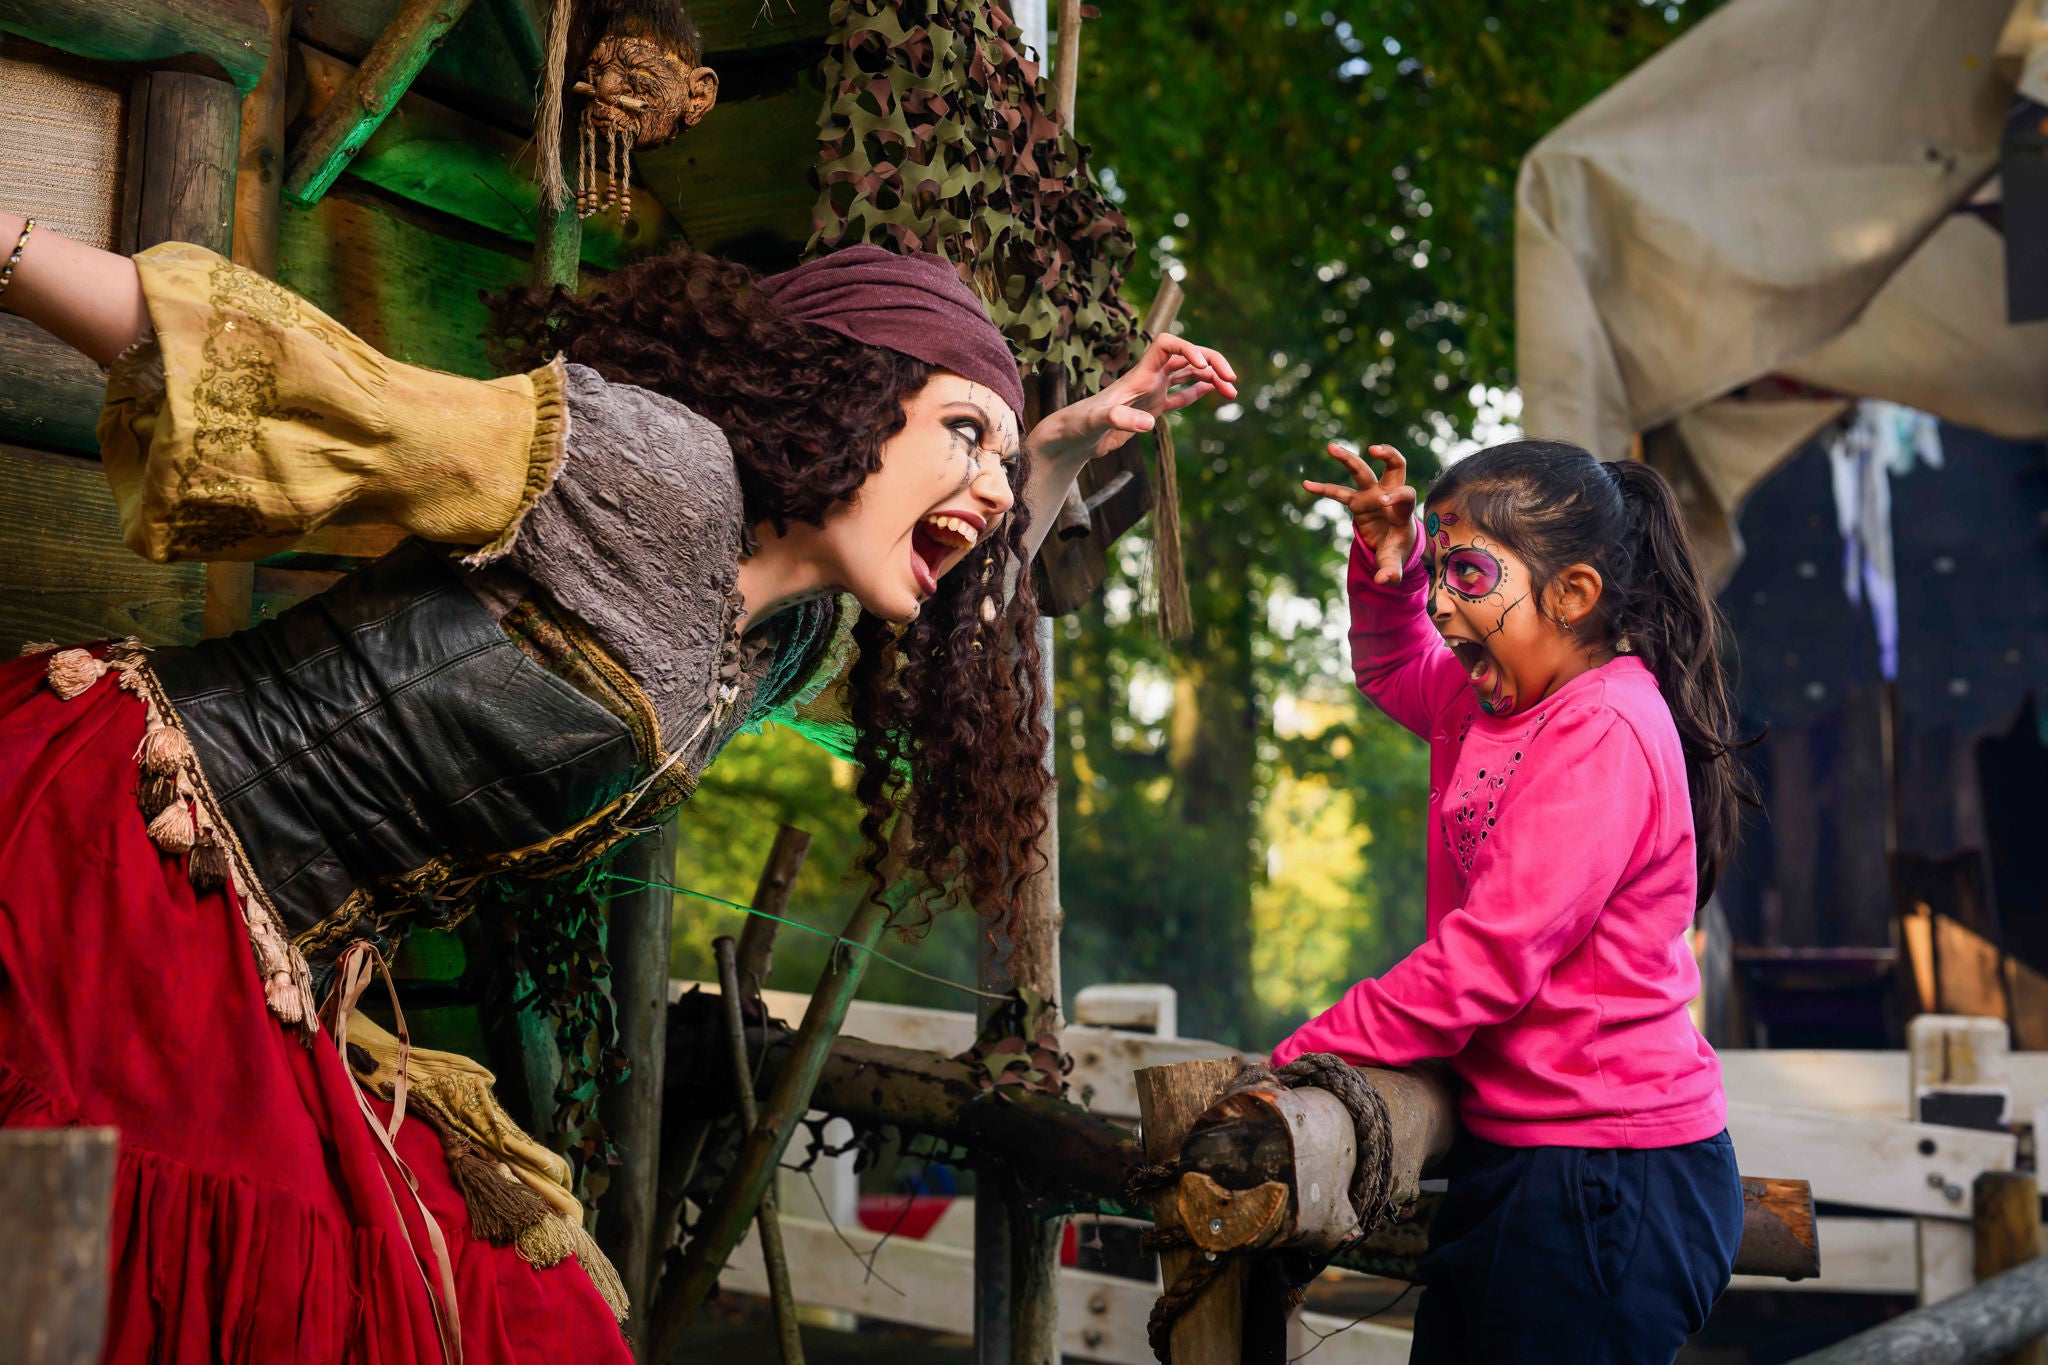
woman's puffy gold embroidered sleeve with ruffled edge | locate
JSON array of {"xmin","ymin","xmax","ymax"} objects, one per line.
[{"xmin": 98, "ymin": 241, "xmax": 567, "ymax": 563}]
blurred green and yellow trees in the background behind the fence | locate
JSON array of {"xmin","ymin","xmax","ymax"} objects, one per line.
[{"xmin": 676, "ymin": 0, "xmax": 1710, "ymax": 1046}]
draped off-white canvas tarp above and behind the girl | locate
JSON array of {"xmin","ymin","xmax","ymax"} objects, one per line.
[{"xmin": 1516, "ymin": 0, "xmax": 2048, "ymax": 563}]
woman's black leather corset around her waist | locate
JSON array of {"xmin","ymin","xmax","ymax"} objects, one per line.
[{"xmin": 150, "ymin": 542, "xmax": 641, "ymax": 952}]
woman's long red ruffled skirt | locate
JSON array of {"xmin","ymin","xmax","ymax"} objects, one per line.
[{"xmin": 0, "ymin": 659, "xmax": 633, "ymax": 1365}]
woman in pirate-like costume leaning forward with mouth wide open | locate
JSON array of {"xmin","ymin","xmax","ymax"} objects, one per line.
[{"xmin": 0, "ymin": 213, "xmax": 1235, "ymax": 1363}]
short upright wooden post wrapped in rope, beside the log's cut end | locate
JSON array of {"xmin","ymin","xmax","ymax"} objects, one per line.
[{"xmin": 1137, "ymin": 1058, "xmax": 1245, "ymax": 1365}]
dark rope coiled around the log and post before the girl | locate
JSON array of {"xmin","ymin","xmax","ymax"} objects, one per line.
[{"xmin": 1126, "ymin": 1052, "xmax": 1395, "ymax": 1365}]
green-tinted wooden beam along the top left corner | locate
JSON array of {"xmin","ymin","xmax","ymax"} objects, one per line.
[{"xmin": 0, "ymin": 0, "xmax": 270, "ymax": 94}]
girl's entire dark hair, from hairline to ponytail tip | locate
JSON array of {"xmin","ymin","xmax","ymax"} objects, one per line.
[{"xmin": 1430, "ymin": 440, "xmax": 1757, "ymax": 905}]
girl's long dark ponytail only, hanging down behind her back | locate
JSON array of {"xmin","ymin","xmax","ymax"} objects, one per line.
[{"xmin": 1606, "ymin": 460, "xmax": 1755, "ymax": 905}]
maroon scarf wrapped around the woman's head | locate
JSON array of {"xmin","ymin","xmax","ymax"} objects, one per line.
[{"xmin": 762, "ymin": 246, "xmax": 1024, "ymax": 424}]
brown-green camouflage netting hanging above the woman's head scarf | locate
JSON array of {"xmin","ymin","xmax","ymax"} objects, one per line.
[{"xmin": 807, "ymin": 0, "xmax": 1139, "ymax": 395}]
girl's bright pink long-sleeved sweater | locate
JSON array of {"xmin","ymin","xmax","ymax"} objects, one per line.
[{"xmin": 1274, "ymin": 527, "xmax": 1726, "ymax": 1148}]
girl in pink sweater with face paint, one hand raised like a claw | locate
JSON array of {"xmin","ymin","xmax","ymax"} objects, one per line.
[{"xmin": 1274, "ymin": 440, "xmax": 1747, "ymax": 1365}]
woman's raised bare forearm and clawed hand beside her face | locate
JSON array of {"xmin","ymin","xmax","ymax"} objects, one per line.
[{"xmin": 1024, "ymin": 336, "xmax": 1237, "ymax": 555}]
